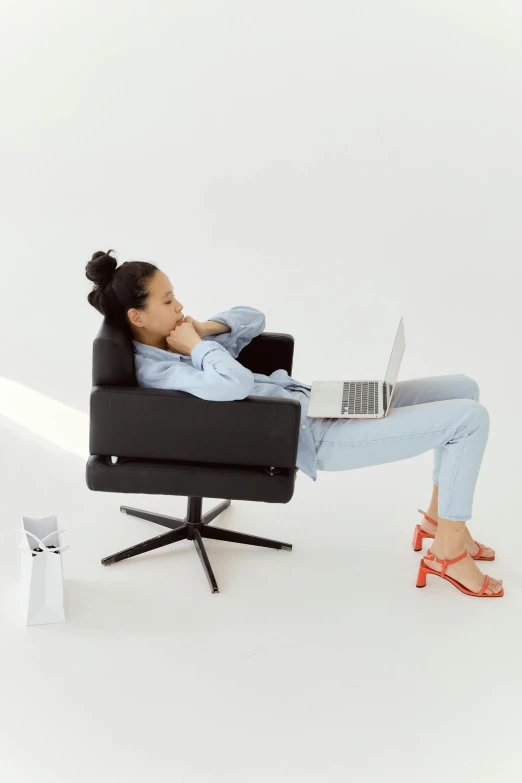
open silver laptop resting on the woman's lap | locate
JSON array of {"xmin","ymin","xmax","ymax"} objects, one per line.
[{"xmin": 306, "ymin": 318, "xmax": 406, "ymax": 419}]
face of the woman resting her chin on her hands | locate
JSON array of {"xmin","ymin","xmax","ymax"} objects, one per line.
[{"xmin": 128, "ymin": 269, "xmax": 183, "ymax": 345}]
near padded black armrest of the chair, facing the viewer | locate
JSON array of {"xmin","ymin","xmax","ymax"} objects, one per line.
[{"xmin": 89, "ymin": 388, "xmax": 301, "ymax": 469}]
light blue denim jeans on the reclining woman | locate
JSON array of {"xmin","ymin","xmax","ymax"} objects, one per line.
[{"xmin": 312, "ymin": 375, "xmax": 489, "ymax": 522}]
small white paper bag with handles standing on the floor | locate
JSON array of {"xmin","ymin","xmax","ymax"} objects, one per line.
[{"xmin": 18, "ymin": 515, "xmax": 69, "ymax": 625}]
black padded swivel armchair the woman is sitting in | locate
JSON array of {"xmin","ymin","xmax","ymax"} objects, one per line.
[{"xmin": 86, "ymin": 318, "xmax": 300, "ymax": 593}]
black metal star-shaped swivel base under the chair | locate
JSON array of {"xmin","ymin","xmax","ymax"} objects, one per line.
[{"xmin": 101, "ymin": 497, "xmax": 292, "ymax": 593}]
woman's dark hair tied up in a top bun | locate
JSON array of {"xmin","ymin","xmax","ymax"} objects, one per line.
[{"xmin": 85, "ymin": 250, "xmax": 158, "ymax": 332}]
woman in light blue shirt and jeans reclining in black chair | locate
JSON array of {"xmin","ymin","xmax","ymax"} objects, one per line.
[{"xmin": 86, "ymin": 250, "xmax": 504, "ymax": 597}]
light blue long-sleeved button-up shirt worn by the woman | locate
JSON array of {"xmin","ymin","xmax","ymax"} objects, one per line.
[{"xmin": 133, "ymin": 306, "xmax": 328, "ymax": 481}]
